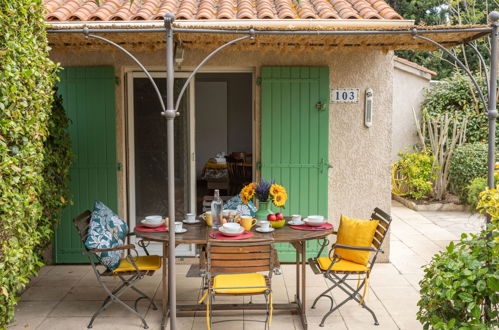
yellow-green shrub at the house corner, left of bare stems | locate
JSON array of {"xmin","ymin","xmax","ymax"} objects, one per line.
[{"xmin": 393, "ymin": 151, "xmax": 435, "ymax": 200}]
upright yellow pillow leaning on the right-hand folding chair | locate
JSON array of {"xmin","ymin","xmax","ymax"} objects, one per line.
[{"xmin": 334, "ymin": 215, "xmax": 379, "ymax": 266}]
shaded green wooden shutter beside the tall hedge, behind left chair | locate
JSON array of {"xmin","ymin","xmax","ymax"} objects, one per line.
[{"xmin": 54, "ymin": 67, "xmax": 118, "ymax": 263}]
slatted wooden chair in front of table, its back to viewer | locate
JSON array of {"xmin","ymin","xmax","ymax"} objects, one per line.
[{"xmin": 199, "ymin": 240, "xmax": 274, "ymax": 330}]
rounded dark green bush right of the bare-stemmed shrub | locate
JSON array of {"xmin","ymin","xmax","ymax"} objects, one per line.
[{"xmin": 449, "ymin": 143, "xmax": 487, "ymax": 202}]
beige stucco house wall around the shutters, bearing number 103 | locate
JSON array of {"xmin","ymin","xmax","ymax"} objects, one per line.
[{"xmin": 51, "ymin": 43, "xmax": 394, "ymax": 261}]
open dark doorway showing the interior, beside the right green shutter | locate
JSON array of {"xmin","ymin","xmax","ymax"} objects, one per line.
[{"xmin": 195, "ymin": 73, "xmax": 254, "ymax": 213}]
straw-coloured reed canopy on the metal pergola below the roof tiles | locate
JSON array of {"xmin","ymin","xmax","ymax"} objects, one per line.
[{"xmin": 47, "ymin": 19, "xmax": 491, "ymax": 51}]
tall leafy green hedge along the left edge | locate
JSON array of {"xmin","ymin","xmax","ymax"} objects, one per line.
[{"xmin": 0, "ymin": 0, "xmax": 70, "ymax": 328}]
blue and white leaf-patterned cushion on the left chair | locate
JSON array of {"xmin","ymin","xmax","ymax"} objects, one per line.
[{"xmin": 85, "ymin": 201, "xmax": 128, "ymax": 270}]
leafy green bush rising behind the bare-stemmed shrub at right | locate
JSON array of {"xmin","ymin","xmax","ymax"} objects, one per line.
[{"xmin": 421, "ymin": 71, "xmax": 488, "ymax": 143}]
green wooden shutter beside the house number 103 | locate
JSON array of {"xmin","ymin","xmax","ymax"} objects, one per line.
[{"xmin": 261, "ymin": 67, "xmax": 329, "ymax": 261}]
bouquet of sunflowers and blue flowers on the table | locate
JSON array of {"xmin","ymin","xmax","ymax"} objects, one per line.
[{"xmin": 240, "ymin": 179, "xmax": 288, "ymax": 207}]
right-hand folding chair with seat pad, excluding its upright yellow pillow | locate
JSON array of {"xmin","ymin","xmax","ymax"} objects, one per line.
[{"xmin": 308, "ymin": 208, "xmax": 392, "ymax": 327}]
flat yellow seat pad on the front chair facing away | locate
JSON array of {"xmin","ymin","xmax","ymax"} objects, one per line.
[{"xmin": 213, "ymin": 273, "xmax": 268, "ymax": 294}]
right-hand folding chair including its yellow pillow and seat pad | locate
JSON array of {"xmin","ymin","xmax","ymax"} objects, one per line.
[{"xmin": 308, "ymin": 208, "xmax": 392, "ymax": 327}]
